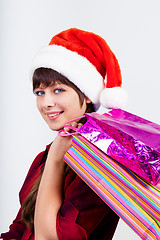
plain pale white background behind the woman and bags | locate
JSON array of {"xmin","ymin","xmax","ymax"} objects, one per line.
[{"xmin": 0, "ymin": 0, "xmax": 160, "ymax": 240}]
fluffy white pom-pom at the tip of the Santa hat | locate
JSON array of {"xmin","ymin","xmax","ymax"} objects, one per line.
[{"xmin": 100, "ymin": 87, "xmax": 127, "ymax": 109}]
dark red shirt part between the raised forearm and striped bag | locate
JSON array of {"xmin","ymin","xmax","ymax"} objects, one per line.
[{"xmin": 57, "ymin": 171, "xmax": 118, "ymax": 240}]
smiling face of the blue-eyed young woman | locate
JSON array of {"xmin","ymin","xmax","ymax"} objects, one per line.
[{"xmin": 34, "ymin": 82, "xmax": 91, "ymax": 131}]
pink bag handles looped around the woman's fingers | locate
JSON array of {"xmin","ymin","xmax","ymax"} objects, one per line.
[{"xmin": 58, "ymin": 115, "xmax": 85, "ymax": 137}]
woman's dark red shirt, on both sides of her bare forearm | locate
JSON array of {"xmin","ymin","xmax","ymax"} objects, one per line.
[{"xmin": 1, "ymin": 145, "xmax": 119, "ymax": 240}]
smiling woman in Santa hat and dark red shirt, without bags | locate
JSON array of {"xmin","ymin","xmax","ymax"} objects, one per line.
[{"xmin": 1, "ymin": 28, "xmax": 125, "ymax": 240}]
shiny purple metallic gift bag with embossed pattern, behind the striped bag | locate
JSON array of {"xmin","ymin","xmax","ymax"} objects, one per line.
[{"xmin": 79, "ymin": 109, "xmax": 160, "ymax": 185}]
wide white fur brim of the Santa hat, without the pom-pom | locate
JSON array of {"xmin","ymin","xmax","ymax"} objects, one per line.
[{"xmin": 31, "ymin": 45, "xmax": 103, "ymax": 105}]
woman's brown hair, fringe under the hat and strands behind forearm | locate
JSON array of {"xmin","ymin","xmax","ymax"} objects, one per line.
[{"xmin": 22, "ymin": 68, "xmax": 95, "ymax": 232}]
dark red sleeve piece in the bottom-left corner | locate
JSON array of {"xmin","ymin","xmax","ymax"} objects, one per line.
[{"xmin": 0, "ymin": 208, "xmax": 25, "ymax": 239}]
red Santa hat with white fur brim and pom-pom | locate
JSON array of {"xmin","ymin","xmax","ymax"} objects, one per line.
[{"xmin": 31, "ymin": 28, "xmax": 126, "ymax": 109}]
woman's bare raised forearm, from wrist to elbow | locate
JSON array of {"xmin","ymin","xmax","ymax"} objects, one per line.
[{"xmin": 34, "ymin": 136, "xmax": 72, "ymax": 240}]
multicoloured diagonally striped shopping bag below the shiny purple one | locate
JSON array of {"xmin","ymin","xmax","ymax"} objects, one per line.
[{"xmin": 64, "ymin": 135, "xmax": 160, "ymax": 240}]
